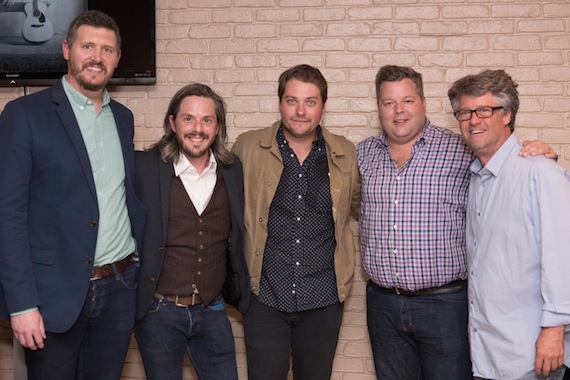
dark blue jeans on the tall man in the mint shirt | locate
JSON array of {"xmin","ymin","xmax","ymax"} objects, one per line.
[{"xmin": 25, "ymin": 265, "xmax": 137, "ymax": 380}]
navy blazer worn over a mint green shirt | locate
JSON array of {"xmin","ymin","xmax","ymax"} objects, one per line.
[{"xmin": 0, "ymin": 81, "xmax": 145, "ymax": 333}]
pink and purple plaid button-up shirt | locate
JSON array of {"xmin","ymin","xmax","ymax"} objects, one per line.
[{"xmin": 357, "ymin": 119, "xmax": 473, "ymax": 291}]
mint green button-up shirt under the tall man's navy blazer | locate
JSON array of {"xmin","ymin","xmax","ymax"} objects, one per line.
[{"xmin": 63, "ymin": 76, "xmax": 135, "ymax": 266}]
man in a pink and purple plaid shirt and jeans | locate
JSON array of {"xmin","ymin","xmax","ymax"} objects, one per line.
[{"xmin": 357, "ymin": 66, "xmax": 556, "ymax": 380}]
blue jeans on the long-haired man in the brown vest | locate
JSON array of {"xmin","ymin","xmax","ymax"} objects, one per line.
[{"xmin": 135, "ymin": 296, "xmax": 238, "ymax": 380}]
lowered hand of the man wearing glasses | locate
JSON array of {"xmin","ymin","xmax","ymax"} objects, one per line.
[{"xmin": 534, "ymin": 326, "xmax": 564, "ymax": 377}]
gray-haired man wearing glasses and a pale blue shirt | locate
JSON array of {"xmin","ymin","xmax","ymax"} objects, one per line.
[{"xmin": 448, "ymin": 70, "xmax": 570, "ymax": 380}]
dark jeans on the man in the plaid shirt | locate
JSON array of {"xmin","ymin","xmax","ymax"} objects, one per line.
[{"xmin": 366, "ymin": 282, "xmax": 473, "ymax": 380}]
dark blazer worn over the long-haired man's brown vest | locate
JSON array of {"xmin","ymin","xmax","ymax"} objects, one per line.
[{"xmin": 135, "ymin": 148, "xmax": 250, "ymax": 319}]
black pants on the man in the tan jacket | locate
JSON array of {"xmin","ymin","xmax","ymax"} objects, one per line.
[{"xmin": 243, "ymin": 296, "xmax": 343, "ymax": 380}]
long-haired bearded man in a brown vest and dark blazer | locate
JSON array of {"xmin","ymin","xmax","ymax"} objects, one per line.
[{"xmin": 135, "ymin": 83, "xmax": 249, "ymax": 380}]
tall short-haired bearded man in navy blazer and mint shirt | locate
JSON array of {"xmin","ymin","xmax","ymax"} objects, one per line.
[{"xmin": 0, "ymin": 11, "xmax": 145, "ymax": 380}]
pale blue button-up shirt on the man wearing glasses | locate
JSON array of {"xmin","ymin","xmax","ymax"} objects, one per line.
[{"xmin": 466, "ymin": 135, "xmax": 570, "ymax": 379}]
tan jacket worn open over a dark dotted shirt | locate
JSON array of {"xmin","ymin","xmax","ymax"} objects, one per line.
[{"xmin": 232, "ymin": 121, "xmax": 360, "ymax": 302}]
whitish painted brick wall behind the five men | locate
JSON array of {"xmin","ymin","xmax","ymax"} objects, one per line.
[{"xmin": 0, "ymin": 0, "xmax": 570, "ymax": 380}]
